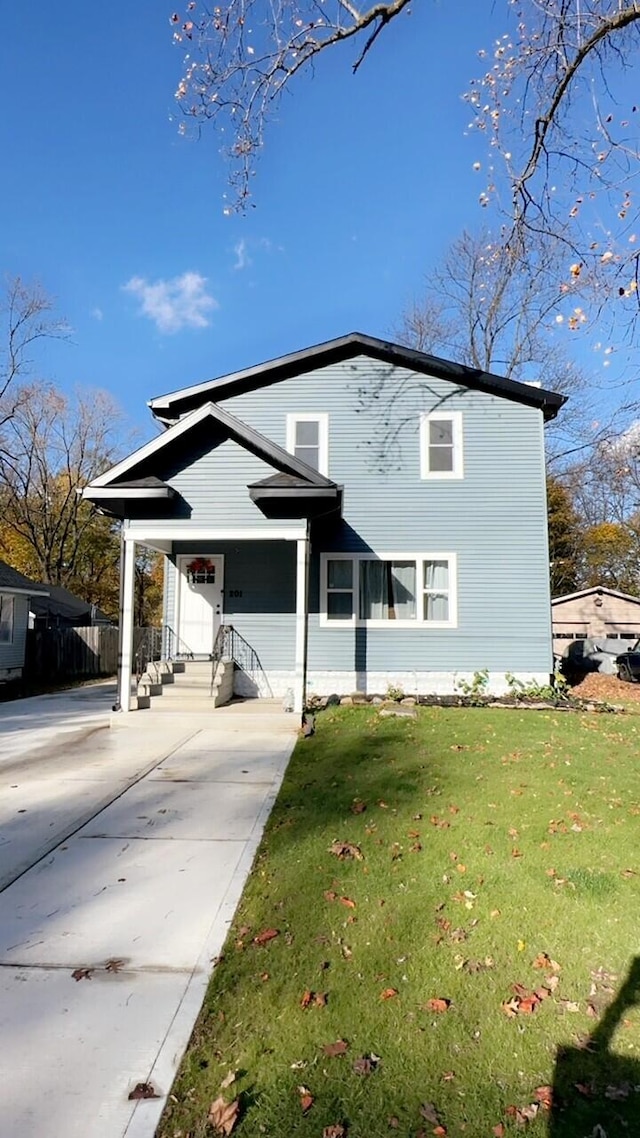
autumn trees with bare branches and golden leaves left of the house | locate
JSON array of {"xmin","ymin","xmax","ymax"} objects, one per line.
[{"xmin": 0, "ymin": 280, "xmax": 162, "ymax": 624}]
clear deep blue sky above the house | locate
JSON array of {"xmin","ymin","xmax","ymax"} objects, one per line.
[{"xmin": 0, "ymin": 0, "xmax": 619, "ymax": 435}]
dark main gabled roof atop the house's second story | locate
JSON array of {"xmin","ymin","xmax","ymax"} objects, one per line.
[{"xmin": 148, "ymin": 332, "xmax": 566, "ymax": 422}]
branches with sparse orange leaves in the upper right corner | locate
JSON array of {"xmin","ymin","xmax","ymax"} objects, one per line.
[{"xmin": 466, "ymin": 0, "xmax": 640, "ymax": 312}]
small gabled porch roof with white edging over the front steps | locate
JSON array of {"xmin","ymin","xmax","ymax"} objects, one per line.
[{"xmin": 83, "ymin": 403, "xmax": 334, "ymax": 489}]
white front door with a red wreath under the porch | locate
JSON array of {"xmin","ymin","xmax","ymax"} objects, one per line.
[{"xmin": 178, "ymin": 553, "xmax": 224, "ymax": 657}]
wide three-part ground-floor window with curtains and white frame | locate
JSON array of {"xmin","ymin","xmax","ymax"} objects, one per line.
[{"xmin": 320, "ymin": 553, "xmax": 458, "ymax": 628}]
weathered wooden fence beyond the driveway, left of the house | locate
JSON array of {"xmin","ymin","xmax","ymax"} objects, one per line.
[{"xmin": 24, "ymin": 625, "xmax": 117, "ymax": 683}]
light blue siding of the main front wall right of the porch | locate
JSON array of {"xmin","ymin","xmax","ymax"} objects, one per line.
[{"xmin": 218, "ymin": 357, "xmax": 552, "ymax": 673}]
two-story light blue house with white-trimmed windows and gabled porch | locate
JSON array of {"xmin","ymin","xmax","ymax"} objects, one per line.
[{"xmin": 84, "ymin": 333, "xmax": 564, "ymax": 710}]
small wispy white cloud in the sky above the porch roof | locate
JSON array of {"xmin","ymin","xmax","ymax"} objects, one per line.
[{"xmin": 122, "ymin": 272, "xmax": 219, "ymax": 332}]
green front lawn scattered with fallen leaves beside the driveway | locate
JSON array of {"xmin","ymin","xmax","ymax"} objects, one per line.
[{"xmin": 157, "ymin": 708, "xmax": 640, "ymax": 1138}]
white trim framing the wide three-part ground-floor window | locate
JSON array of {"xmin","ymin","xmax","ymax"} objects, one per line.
[{"xmin": 319, "ymin": 550, "xmax": 458, "ymax": 632}]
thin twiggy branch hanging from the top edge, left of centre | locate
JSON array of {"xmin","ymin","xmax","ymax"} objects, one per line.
[{"xmin": 171, "ymin": 0, "xmax": 409, "ymax": 208}]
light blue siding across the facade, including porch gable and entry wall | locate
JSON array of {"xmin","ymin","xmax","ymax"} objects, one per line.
[{"xmin": 148, "ymin": 356, "xmax": 551, "ymax": 673}]
